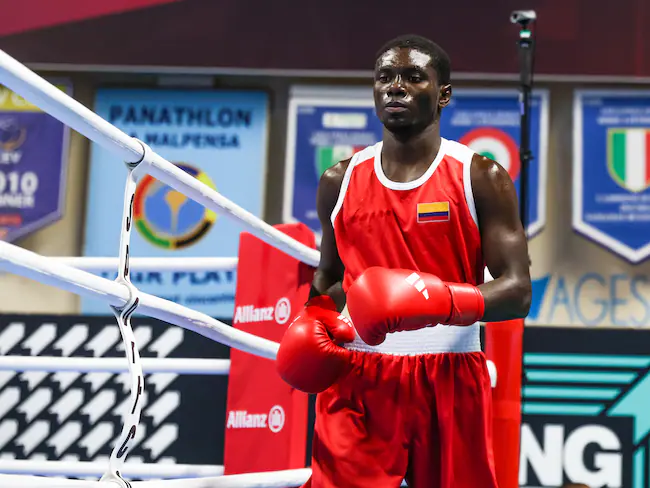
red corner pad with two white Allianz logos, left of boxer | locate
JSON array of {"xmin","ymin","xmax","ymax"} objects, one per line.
[{"xmin": 224, "ymin": 224, "xmax": 315, "ymax": 474}]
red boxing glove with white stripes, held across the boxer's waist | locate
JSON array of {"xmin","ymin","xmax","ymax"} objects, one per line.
[{"xmin": 347, "ymin": 267, "xmax": 485, "ymax": 346}]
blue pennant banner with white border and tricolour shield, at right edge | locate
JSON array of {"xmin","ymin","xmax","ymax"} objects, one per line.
[{"xmin": 573, "ymin": 90, "xmax": 650, "ymax": 263}]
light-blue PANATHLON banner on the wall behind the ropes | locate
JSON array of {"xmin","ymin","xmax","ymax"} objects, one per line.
[{"xmin": 82, "ymin": 89, "xmax": 268, "ymax": 318}]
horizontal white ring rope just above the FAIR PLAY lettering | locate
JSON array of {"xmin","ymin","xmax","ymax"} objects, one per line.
[{"xmin": 48, "ymin": 256, "xmax": 239, "ymax": 271}]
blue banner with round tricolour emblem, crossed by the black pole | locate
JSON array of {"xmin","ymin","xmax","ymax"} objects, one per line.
[{"xmin": 440, "ymin": 89, "xmax": 549, "ymax": 237}]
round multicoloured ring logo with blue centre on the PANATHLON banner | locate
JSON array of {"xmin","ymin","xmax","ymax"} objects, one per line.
[{"xmin": 133, "ymin": 163, "xmax": 217, "ymax": 249}]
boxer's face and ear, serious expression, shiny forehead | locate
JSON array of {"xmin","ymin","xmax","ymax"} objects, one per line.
[{"xmin": 374, "ymin": 48, "xmax": 451, "ymax": 131}]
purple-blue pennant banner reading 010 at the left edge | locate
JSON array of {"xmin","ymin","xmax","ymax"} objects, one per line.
[{"xmin": 0, "ymin": 83, "xmax": 71, "ymax": 242}]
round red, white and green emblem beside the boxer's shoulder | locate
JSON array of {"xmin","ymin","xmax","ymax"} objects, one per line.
[{"xmin": 458, "ymin": 127, "xmax": 521, "ymax": 181}]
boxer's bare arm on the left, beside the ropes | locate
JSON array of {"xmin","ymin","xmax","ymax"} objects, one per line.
[{"xmin": 309, "ymin": 159, "xmax": 350, "ymax": 311}]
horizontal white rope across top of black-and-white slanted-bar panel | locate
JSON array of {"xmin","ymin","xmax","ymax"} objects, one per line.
[{"xmin": 0, "ymin": 356, "xmax": 230, "ymax": 375}]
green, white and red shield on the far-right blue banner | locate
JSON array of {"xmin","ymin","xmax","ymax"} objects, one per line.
[{"xmin": 607, "ymin": 127, "xmax": 650, "ymax": 193}]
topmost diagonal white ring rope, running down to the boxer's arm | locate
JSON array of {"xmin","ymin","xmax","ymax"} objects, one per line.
[{"xmin": 0, "ymin": 50, "xmax": 319, "ymax": 266}]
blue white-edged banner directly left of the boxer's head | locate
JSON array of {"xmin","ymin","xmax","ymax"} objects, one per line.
[{"xmin": 283, "ymin": 86, "xmax": 383, "ymax": 233}]
